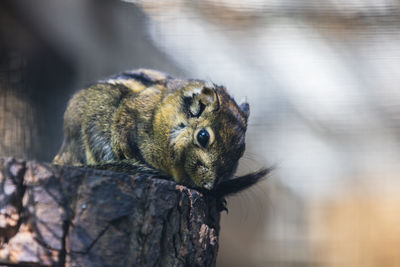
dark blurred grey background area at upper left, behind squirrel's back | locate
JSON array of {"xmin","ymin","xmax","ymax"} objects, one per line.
[{"xmin": 0, "ymin": 0, "xmax": 183, "ymax": 161}]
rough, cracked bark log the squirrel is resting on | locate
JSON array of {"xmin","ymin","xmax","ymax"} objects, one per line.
[{"xmin": 0, "ymin": 158, "xmax": 220, "ymax": 266}]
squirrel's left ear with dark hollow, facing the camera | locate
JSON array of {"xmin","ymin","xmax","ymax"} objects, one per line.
[{"xmin": 186, "ymin": 87, "xmax": 219, "ymax": 117}]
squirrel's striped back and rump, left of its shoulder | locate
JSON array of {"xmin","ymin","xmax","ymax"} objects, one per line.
[{"xmin": 53, "ymin": 70, "xmax": 171, "ymax": 166}]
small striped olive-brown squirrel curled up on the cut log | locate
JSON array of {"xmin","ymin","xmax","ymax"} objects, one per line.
[{"xmin": 53, "ymin": 69, "xmax": 269, "ymax": 196}]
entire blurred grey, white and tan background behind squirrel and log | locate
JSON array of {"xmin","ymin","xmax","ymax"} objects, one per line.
[{"xmin": 0, "ymin": 0, "xmax": 400, "ymax": 267}]
